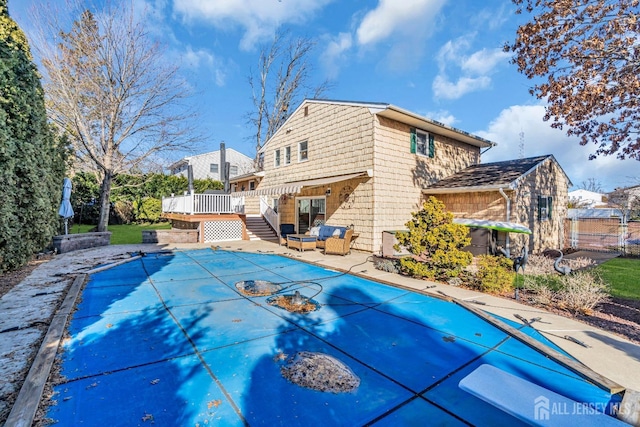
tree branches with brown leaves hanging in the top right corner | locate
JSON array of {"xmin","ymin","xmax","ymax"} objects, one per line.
[{"xmin": 505, "ymin": 0, "xmax": 640, "ymax": 160}]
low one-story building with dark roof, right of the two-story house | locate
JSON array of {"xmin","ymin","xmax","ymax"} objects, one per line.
[{"xmin": 423, "ymin": 155, "xmax": 572, "ymax": 255}]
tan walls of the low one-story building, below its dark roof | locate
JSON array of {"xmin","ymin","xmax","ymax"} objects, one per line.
[{"xmin": 436, "ymin": 159, "xmax": 569, "ymax": 254}]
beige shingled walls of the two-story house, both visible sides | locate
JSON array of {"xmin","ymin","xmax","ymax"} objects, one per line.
[{"xmin": 259, "ymin": 102, "xmax": 480, "ymax": 252}]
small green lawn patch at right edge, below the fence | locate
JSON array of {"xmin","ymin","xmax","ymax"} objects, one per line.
[{"xmin": 597, "ymin": 258, "xmax": 640, "ymax": 300}]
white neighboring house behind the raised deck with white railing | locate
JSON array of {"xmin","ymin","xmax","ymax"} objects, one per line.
[{"xmin": 169, "ymin": 148, "xmax": 253, "ymax": 181}]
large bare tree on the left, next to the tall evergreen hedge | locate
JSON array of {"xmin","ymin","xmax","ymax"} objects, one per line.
[{"xmin": 30, "ymin": 0, "xmax": 195, "ymax": 231}]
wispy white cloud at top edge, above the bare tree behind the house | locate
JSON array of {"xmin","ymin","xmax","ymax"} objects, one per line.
[{"xmin": 174, "ymin": 0, "xmax": 333, "ymax": 50}]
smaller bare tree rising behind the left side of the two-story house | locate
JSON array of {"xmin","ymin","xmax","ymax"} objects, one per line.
[{"xmin": 248, "ymin": 30, "xmax": 330, "ymax": 167}]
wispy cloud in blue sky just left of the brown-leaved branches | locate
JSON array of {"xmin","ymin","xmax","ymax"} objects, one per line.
[{"xmin": 432, "ymin": 34, "xmax": 509, "ymax": 99}]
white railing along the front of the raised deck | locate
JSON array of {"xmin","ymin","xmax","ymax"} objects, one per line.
[{"xmin": 162, "ymin": 193, "xmax": 244, "ymax": 215}]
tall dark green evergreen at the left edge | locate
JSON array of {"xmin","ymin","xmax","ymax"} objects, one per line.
[{"xmin": 0, "ymin": 0, "xmax": 65, "ymax": 271}]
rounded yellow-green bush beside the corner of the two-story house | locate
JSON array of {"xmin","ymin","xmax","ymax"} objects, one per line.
[{"xmin": 395, "ymin": 196, "xmax": 473, "ymax": 280}]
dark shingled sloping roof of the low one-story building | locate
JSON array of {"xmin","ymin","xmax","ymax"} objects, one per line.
[{"xmin": 423, "ymin": 154, "xmax": 570, "ymax": 194}]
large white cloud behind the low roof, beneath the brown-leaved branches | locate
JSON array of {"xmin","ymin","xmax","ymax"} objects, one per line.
[{"xmin": 475, "ymin": 105, "xmax": 638, "ymax": 191}]
